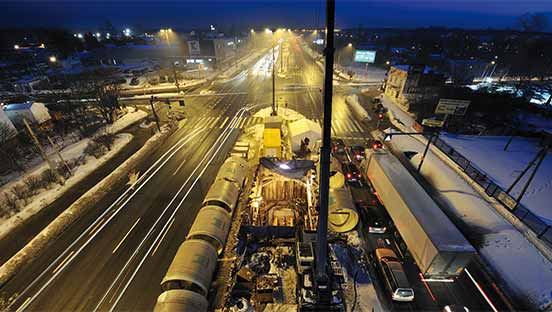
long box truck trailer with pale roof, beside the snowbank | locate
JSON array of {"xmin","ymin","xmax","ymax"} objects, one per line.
[{"xmin": 361, "ymin": 149, "xmax": 476, "ymax": 280}]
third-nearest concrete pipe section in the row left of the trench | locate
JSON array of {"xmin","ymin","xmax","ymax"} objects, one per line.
[{"xmin": 186, "ymin": 206, "xmax": 231, "ymax": 255}]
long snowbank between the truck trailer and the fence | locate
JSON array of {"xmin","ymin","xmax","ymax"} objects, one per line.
[{"xmin": 390, "ymin": 132, "xmax": 552, "ymax": 309}]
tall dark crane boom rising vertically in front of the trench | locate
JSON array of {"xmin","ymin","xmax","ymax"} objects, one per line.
[{"xmin": 316, "ymin": 0, "xmax": 335, "ymax": 304}]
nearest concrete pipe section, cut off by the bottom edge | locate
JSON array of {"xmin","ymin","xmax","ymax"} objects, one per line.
[{"xmin": 153, "ymin": 289, "xmax": 209, "ymax": 312}]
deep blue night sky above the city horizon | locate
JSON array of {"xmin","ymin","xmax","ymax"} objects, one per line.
[{"xmin": 0, "ymin": 0, "xmax": 552, "ymax": 31}]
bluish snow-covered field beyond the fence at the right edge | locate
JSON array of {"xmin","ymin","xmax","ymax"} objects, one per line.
[{"xmin": 440, "ymin": 134, "xmax": 552, "ymax": 224}]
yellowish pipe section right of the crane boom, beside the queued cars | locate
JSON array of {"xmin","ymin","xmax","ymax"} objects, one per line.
[{"xmin": 328, "ymin": 188, "xmax": 358, "ymax": 233}]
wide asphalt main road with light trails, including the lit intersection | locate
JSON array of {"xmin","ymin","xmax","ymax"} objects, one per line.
[{"xmin": 0, "ymin": 34, "xmax": 512, "ymax": 311}]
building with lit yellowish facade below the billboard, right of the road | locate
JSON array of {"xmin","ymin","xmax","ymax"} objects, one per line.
[{"xmin": 385, "ymin": 65, "xmax": 445, "ymax": 119}]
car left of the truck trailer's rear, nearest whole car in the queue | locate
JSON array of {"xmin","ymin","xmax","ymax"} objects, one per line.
[{"xmin": 375, "ymin": 248, "xmax": 414, "ymax": 302}]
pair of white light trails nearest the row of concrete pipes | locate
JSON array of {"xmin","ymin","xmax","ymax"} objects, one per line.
[{"xmin": 93, "ymin": 108, "xmax": 245, "ymax": 311}]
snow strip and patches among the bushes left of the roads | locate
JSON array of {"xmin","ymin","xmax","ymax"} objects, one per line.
[{"xmin": 0, "ymin": 133, "xmax": 132, "ymax": 237}]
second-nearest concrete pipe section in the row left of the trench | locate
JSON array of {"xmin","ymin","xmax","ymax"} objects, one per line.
[{"xmin": 161, "ymin": 239, "xmax": 218, "ymax": 296}]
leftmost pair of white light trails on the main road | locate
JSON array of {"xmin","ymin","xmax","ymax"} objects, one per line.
[{"xmin": 6, "ymin": 128, "xmax": 208, "ymax": 309}]
